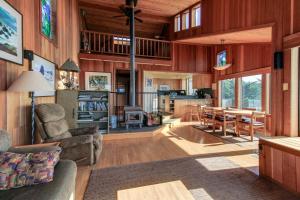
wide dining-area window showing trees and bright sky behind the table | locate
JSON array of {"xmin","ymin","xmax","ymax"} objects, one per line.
[{"xmin": 240, "ymin": 75, "xmax": 262, "ymax": 110}]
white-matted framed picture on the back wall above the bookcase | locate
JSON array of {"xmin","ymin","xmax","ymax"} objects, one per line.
[{"xmin": 85, "ymin": 72, "xmax": 111, "ymax": 91}]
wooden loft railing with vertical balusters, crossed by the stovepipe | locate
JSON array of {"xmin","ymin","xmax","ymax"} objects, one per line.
[{"xmin": 80, "ymin": 31, "xmax": 171, "ymax": 59}]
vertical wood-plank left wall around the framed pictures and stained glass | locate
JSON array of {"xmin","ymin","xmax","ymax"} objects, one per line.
[{"xmin": 0, "ymin": 0, "xmax": 79, "ymax": 145}]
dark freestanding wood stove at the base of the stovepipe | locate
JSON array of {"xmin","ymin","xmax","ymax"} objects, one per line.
[{"xmin": 124, "ymin": 106, "xmax": 144, "ymax": 130}]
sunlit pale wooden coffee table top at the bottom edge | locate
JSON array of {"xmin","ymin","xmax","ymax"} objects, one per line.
[{"xmin": 118, "ymin": 181, "xmax": 195, "ymax": 200}]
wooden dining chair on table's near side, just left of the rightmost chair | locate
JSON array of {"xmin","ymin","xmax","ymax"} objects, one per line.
[{"xmin": 213, "ymin": 110, "xmax": 236, "ymax": 136}]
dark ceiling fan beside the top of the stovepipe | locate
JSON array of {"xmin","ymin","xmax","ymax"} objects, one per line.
[{"xmin": 113, "ymin": 0, "xmax": 143, "ymax": 25}]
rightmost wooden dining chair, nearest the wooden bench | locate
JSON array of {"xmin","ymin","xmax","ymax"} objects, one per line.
[{"xmin": 237, "ymin": 111, "xmax": 267, "ymax": 141}]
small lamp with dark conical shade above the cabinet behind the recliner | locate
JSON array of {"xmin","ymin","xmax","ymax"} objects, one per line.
[{"xmin": 58, "ymin": 58, "xmax": 80, "ymax": 90}]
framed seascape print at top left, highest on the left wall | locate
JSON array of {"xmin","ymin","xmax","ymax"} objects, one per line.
[{"xmin": 0, "ymin": 0, "xmax": 24, "ymax": 65}]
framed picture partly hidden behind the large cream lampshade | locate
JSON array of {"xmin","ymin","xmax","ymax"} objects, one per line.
[{"xmin": 31, "ymin": 54, "xmax": 55, "ymax": 97}]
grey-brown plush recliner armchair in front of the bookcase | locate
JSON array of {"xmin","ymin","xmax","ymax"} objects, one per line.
[{"xmin": 35, "ymin": 104, "xmax": 103, "ymax": 165}]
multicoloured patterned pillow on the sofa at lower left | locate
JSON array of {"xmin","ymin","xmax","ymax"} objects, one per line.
[{"xmin": 0, "ymin": 150, "xmax": 61, "ymax": 190}]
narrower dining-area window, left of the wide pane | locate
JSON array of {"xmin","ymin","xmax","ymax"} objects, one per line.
[{"xmin": 221, "ymin": 79, "xmax": 235, "ymax": 107}]
